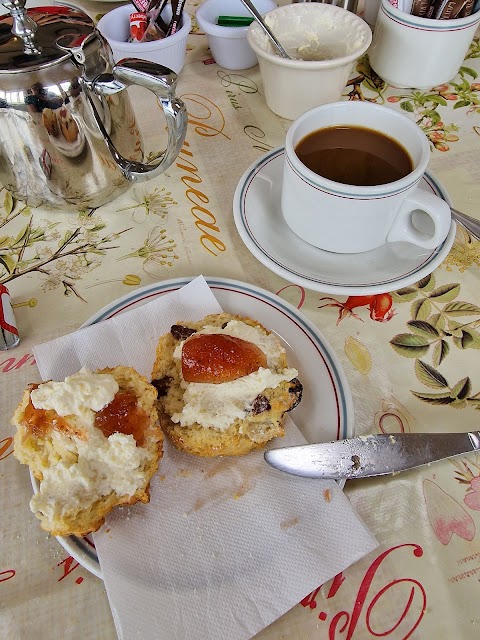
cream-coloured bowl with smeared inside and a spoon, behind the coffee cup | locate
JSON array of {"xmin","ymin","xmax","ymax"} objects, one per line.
[{"xmin": 248, "ymin": 2, "xmax": 372, "ymax": 120}]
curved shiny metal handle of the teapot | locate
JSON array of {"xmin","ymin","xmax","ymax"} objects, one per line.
[{"xmin": 85, "ymin": 58, "xmax": 188, "ymax": 182}]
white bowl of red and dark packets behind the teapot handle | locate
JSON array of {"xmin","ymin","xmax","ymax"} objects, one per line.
[{"xmin": 97, "ymin": 4, "xmax": 192, "ymax": 73}]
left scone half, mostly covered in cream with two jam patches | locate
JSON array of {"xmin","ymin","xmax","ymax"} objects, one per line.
[{"xmin": 12, "ymin": 367, "xmax": 163, "ymax": 536}]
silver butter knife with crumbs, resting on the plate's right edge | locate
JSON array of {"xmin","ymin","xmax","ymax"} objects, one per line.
[{"xmin": 264, "ymin": 431, "xmax": 480, "ymax": 480}]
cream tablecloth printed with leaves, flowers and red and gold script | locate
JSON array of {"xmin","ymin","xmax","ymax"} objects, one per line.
[{"xmin": 0, "ymin": 0, "xmax": 480, "ymax": 640}]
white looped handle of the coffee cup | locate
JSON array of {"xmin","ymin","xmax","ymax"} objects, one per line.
[{"xmin": 387, "ymin": 187, "xmax": 452, "ymax": 249}]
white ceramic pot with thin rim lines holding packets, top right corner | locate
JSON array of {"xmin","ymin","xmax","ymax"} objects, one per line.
[{"xmin": 368, "ymin": 0, "xmax": 480, "ymax": 89}]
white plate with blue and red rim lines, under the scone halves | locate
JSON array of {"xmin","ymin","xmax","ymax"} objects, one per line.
[{"xmin": 31, "ymin": 278, "xmax": 354, "ymax": 578}]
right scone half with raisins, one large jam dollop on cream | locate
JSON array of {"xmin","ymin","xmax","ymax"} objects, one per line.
[{"xmin": 152, "ymin": 313, "xmax": 302, "ymax": 456}]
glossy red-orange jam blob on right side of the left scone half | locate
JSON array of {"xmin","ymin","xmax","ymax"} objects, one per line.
[{"xmin": 95, "ymin": 391, "xmax": 149, "ymax": 446}]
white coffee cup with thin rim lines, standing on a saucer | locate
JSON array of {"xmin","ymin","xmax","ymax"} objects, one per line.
[{"xmin": 281, "ymin": 101, "xmax": 451, "ymax": 253}]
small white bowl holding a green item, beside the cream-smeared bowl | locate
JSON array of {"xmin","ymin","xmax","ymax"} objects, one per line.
[{"xmin": 195, "ymin": 0, "xmax": 277, "ymax": 70}]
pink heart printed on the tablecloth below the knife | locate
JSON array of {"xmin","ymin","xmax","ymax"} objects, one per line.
[{"xmin": 423, "ymin": 480, "xmax": 474, "ymax": 545}]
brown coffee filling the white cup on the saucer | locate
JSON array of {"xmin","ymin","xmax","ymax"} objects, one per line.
[{"xmin": 295, "ymin": 126, "xmax": 413, "ymax": 186}]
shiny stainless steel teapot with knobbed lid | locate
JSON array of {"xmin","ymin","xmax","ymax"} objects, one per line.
[{"xmin": 0, "ymin": 0, "xmax": 187, "ymax": 210}]
